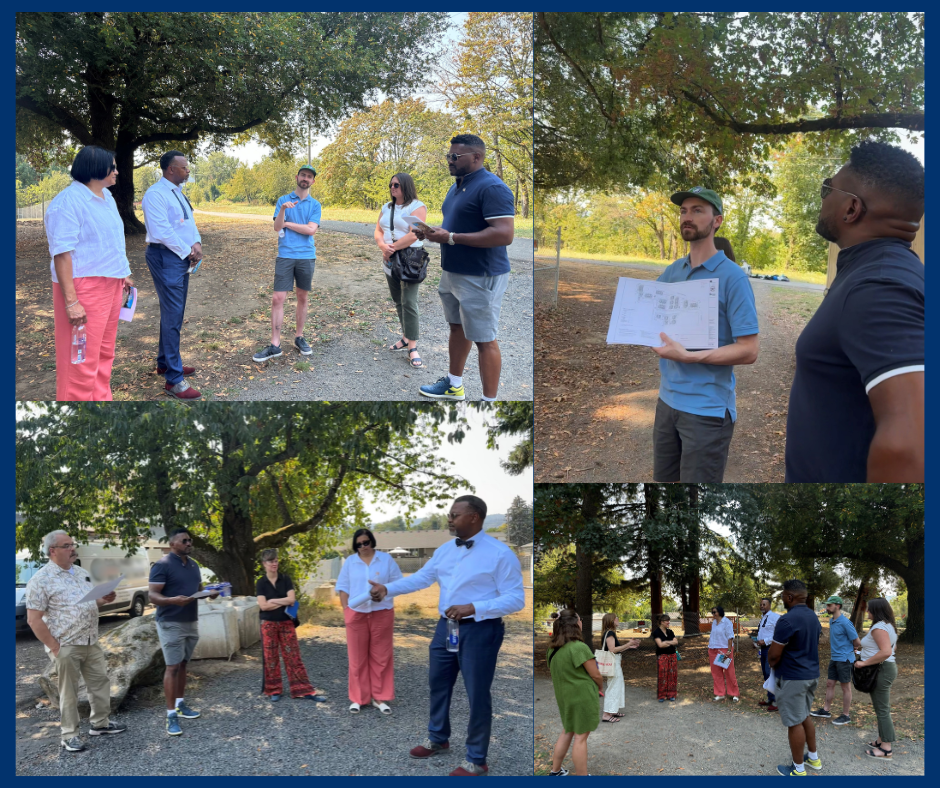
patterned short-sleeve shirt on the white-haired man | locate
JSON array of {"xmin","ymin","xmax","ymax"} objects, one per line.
[{"xmin": 25, "ymin": 561, "xmax": 98, "ymax": 646}]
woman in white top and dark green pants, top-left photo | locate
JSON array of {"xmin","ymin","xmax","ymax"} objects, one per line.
[{"xmin": 375, "ymin": 172, "xmax": 428, "ymax": 367}]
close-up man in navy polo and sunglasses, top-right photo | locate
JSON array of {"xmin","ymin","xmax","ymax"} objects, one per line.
[{"xmin": 786, "ymin": 142, "xmax": 924, "ymax": 482}]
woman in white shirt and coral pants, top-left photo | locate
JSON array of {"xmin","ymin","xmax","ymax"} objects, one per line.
[{"xmin": 45, "ymin": 145, "xmax": 134, "ymax": 402}]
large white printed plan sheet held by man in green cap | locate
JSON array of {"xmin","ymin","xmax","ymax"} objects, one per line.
[{"xmin": 607, "ymin": 276, "xmax": 718, "ymax": 350}]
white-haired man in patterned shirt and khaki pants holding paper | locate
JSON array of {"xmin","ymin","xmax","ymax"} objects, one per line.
[{"xmin": 26, "ymin": 531, "xmax": 127, "ymax": 752}]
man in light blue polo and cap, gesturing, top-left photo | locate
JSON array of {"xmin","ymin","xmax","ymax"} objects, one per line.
[{"xmin": 251, "ymin": 164, "xmax": 320, "ymax": 363}]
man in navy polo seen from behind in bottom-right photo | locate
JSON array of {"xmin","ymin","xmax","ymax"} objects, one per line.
[{"xmin": 767, "ymin": 580, "xmax": 822, "ymax": 777}]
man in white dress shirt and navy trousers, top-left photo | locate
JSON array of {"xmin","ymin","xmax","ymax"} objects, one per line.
[{"xmin": 143, "ymin": 150, "xmax": 202, "ymax": 400}]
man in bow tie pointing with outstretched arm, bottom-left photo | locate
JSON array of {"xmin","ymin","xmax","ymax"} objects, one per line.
[{"xmin": 369, "ymin": 495, "xmax": 525, "ymax": 777}]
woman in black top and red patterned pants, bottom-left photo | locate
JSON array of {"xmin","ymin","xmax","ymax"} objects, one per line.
[{"xmin": 255, "ymin": 550, "xmax": 325, "ymax": 702}]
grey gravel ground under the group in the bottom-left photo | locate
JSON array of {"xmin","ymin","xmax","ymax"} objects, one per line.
[{"xmin": 16, "ymin": 617, "xmax": 533, "ymax": 776}]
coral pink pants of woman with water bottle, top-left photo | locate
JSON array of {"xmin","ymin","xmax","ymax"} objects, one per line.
[{"xmin": 52, "ymin": 276, "xmax": 124, "ymax": 402}]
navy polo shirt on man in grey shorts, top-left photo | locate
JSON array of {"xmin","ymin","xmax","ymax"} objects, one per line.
[{"xmin": 441, "ymin": 169, "xmax": 516, "ymax": 276}]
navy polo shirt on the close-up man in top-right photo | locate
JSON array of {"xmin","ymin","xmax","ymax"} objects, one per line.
[{"xmin": 786, "ymin": 238, "xmax": 924, "ymax": 482}]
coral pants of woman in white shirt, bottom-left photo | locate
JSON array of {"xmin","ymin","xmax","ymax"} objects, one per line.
[{"xmin": 343, "ymin": 607, "xmax": 395, "ymax": 706}]
